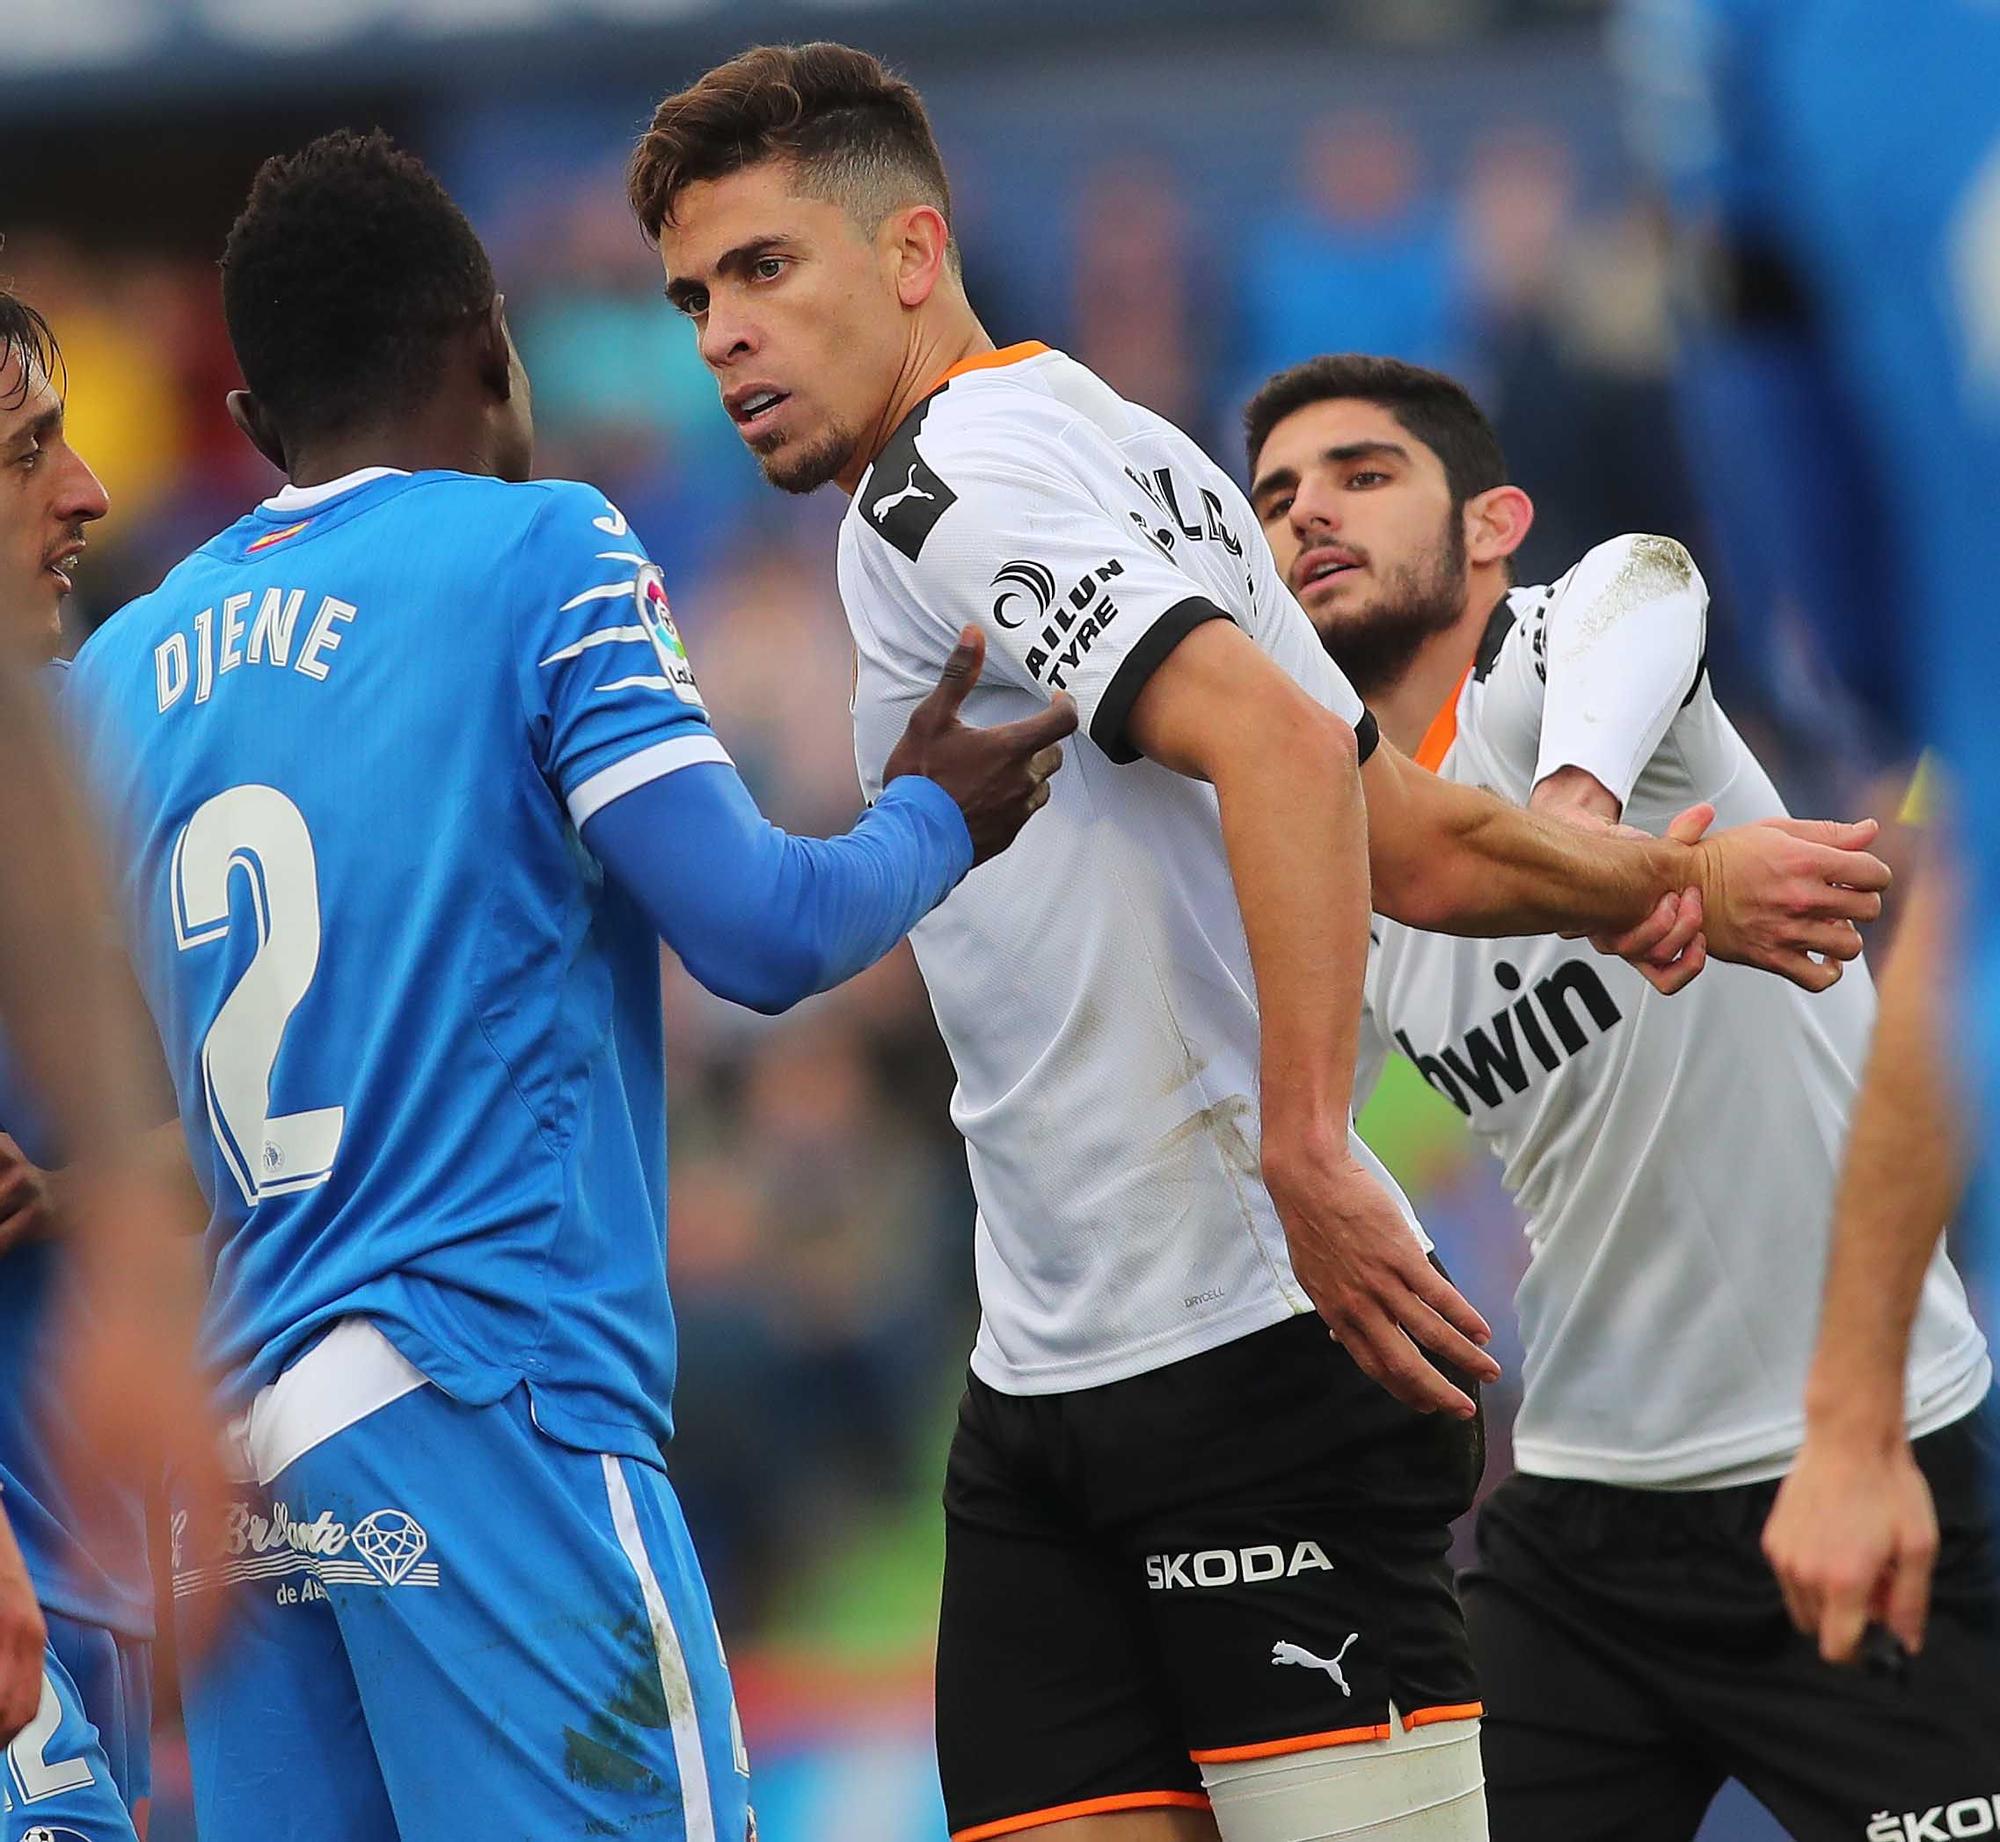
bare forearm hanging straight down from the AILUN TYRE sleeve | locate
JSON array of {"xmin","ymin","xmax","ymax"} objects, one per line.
[{"xmin": 1210, "ymin": 706, "xmax": 1368, "ymax": 1158}]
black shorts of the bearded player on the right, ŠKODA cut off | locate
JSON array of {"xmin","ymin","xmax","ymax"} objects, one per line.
[{"xmin": 1460, "ymin": 1414, "xmax": 2000, "ymax": 1842}]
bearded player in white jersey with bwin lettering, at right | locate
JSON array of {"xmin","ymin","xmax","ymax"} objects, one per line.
[{"xmin": 1248, "ymin": 356, "xmax": 2000, "ymax": 1842}]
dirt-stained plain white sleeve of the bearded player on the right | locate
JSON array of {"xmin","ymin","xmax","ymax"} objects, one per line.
[{"xmin": 1534, "ymin": 536, "xmax": 1708, "ymax": 806}]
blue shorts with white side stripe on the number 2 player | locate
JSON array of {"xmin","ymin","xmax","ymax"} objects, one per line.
[{"xmin": 174, "ymin": 1320, "xmax": 750, "ymax": 1842}]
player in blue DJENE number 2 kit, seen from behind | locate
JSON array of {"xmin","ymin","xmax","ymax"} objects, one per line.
[{"xmin": 68, "ymin": 134, "xmax": 1074, "ymax": 1842}]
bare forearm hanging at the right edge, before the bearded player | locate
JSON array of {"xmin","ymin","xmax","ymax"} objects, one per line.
[{"xmin": 1806, "ymin": 864, "xmax": 1966, "ymax": 1442}]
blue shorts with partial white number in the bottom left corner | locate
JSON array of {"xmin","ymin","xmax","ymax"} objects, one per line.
[{"xmin": 0, "ymin": 1612, "xmax": 152, "ymax": 1842}]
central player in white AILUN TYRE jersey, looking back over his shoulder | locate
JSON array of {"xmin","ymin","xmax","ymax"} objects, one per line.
[{"xmin": 630, "ymin": 46, "xmax": 1880, "ymax": 1842}]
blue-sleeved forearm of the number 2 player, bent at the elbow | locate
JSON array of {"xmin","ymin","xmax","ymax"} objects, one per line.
[{"xmin": 584, "ymin": 764, "xmax": 972, "ymax": 1012}]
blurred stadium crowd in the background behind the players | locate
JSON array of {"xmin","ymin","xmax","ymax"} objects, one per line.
[{"xmin": 0, "ymin": 8, "xmax": 1944, "ymax": 1836}]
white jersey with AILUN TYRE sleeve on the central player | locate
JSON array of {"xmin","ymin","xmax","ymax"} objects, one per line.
[{"xmin": 840, "ymin": 346, "xmax": 1428, "ymax": 1394}]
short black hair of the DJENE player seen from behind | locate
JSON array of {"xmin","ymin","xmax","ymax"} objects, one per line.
[{"xmin": 222, "ymin": 128, "xmax": 494, "ymax": 440}]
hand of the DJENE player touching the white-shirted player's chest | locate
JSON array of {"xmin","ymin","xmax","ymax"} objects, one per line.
[{"xmin": 882, "ymin": 626, "xmax": 1076, "ymax": 864}]
